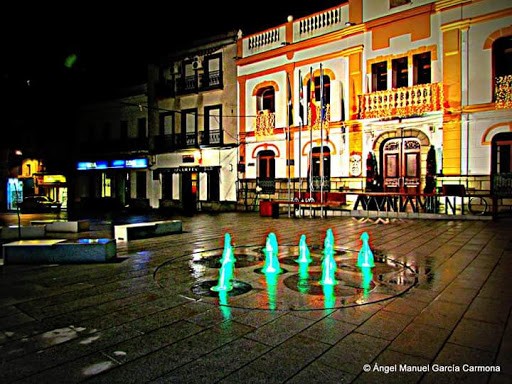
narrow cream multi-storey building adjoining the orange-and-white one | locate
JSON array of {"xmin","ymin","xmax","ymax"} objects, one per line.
[{"xmin": 148, "ymin": 31, "xmax": 240, "ymax": 213}]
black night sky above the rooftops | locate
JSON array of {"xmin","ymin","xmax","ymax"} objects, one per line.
[{"xmin": 0, "ymin": 0, "xmax": 344, "ymax": 160}]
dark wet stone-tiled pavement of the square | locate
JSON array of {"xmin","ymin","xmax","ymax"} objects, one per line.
[{"xmin": 0, "ymin": 213, "xmax": 512, "ymax": 384}]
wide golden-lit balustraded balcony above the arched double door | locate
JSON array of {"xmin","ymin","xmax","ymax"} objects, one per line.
[{"xmin": 359, "ymin": 83, "xmax": 443, "ymax": 119}]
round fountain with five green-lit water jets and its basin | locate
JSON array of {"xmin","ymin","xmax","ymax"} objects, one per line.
[{"xmin": 159, "ymin": 229, "xmax": 417, "ymax": 312}]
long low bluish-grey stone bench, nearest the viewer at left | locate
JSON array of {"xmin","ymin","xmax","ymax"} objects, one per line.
[{"xmin": 2, "ymin": 239, "xmax": 117, "ymax": 265}]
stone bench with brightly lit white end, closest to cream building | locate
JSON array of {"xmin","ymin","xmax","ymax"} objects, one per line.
[{"xmin": 114, "ymin": 220, "xmax": 183, "ymax": 241}]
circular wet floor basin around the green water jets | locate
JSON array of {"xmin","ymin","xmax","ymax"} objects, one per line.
[{"xmin": 154, "ymin": 245, "xmax": 417, "ymax": 311}]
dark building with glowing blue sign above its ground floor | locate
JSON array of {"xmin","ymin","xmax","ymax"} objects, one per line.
[{"xmin": 73, "ymin": 85, "xmax": 151, "ymax": 210}]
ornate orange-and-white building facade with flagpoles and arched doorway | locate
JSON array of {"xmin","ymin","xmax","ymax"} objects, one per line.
[{"xmin": 237, "ymin": 0, "xmax": 512, "ymax": 209}]
